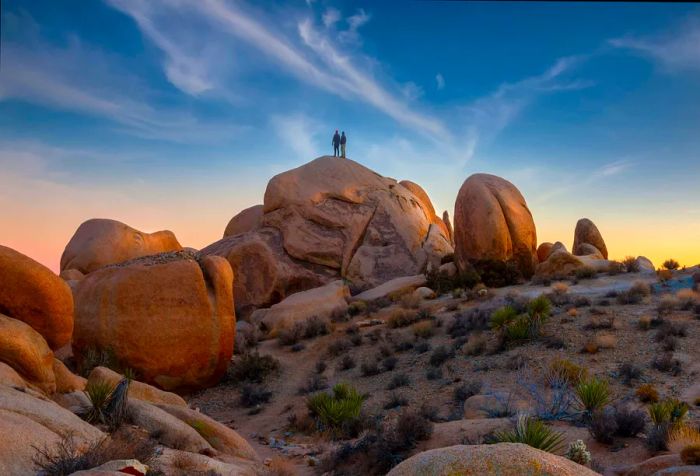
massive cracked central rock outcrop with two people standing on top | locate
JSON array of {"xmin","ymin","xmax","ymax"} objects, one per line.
[{"xmin": 201, "ymin": 157, "xmax": 453, "ymax": 315}]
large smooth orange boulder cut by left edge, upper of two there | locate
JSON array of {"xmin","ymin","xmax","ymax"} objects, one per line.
[{"xmin": 0, "ymin": 246, "xmax": 73, "ymax": 349}]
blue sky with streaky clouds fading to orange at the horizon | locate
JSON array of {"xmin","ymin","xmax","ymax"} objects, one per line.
[{"xmin": 0, "ymin": 0, "xmax": 700, "ymax": 271}]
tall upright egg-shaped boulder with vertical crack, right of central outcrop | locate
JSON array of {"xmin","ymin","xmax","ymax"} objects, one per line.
[{"xmin": 454, "ymin": 174, "xmax": 537, "ymax": 277}]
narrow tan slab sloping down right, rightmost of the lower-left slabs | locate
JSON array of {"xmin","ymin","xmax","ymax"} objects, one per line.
[{"xmin": 158, "ymin": 405, "xmax": 258, "ymax": 460}]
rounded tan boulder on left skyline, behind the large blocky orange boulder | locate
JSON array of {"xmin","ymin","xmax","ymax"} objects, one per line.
[{"xmin": 61, "ymin": 218, "xmax": 182, "ymax": 274}]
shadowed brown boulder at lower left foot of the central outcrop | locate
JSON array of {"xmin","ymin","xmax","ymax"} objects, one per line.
[{"xmin": 200, "ymin": 228, "xmax": 330, "ymax": 318}]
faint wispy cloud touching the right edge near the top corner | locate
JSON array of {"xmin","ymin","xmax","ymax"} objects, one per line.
[{"xmin": 609, "ymin": 16, "xmax": 700, "ymax": 72}]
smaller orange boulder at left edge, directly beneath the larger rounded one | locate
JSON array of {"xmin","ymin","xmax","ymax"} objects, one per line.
[{"xmin": 0, "ymin": 314, "xmax": 56, "ymax": 394}]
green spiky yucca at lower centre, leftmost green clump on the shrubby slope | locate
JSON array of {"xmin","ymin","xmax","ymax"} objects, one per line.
[{"xmin": 306, "ymin": 383, "xmax": 365, "ymax": 437}]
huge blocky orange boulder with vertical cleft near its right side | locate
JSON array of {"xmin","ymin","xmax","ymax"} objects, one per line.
[{"xmin": 73, "ymin": 256, "xmax": 235, "ymax": 390}]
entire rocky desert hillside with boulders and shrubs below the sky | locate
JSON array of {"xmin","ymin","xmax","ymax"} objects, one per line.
[{"xmin": 0, "ymin": 157, "xmax": 700, "ymax": 476}]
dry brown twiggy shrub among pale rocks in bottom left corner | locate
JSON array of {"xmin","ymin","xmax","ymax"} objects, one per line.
[{"xmin": 33, "ymin": 430, "xmax": 157, "ymax": 476}]
